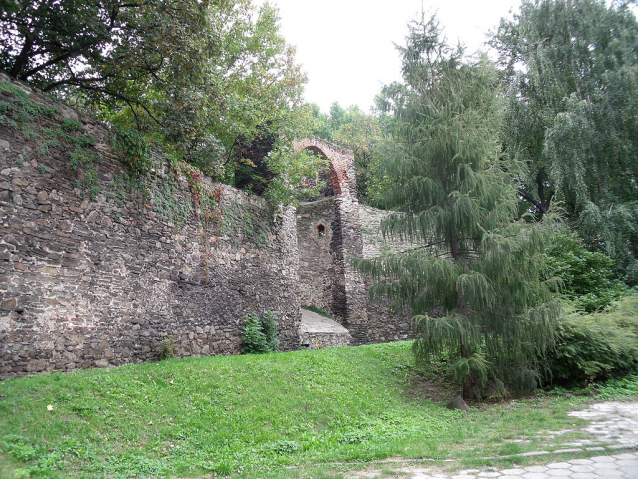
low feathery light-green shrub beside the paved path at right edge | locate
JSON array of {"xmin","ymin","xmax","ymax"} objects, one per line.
[{"xmin": 549, "ymin": 293, "xmax": 638, "ymax": 385}]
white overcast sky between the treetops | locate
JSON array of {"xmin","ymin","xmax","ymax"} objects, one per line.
[{"xmin": 258, "ymin": 0, "xmax": 520, "ymax": 113}]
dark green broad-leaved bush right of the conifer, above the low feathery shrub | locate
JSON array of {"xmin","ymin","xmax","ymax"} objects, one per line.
[{"xmin": 547, "ymin": 232, "xmax": 627, "ymax": 313}]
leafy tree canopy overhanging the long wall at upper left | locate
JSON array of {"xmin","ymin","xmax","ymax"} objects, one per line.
[{"xmin": 0, "ymin": 0, "xmax": 320, "ymax": 201}]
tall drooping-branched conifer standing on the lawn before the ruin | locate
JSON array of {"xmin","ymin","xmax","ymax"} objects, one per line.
[{"xmin": 357, "ymin": 16, "xmax": 558, "ymax": 399}]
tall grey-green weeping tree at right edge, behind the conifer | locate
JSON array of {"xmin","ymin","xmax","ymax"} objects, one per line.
[{"xmin": 492, "ymin": 0, "xmax": 638, "ymax": 283}]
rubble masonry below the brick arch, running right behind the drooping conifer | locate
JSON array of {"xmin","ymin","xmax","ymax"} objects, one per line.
[{"xmin": 297, "ymin": 198, "xmax": 409, "ymax": 344}]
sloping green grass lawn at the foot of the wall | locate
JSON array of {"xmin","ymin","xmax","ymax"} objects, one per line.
[{"xmin": 0, "ymin": 342, "xmax": 638, "ymax": 478}]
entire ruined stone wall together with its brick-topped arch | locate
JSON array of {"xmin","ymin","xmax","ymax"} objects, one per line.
[{"xmin": 0, "ymin": 74, "xmax": 408, "ymax": 378}]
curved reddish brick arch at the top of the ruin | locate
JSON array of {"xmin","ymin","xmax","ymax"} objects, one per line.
[{"xmin": 295, "ymin": 138, "xmax": 357, "ymax": 199}]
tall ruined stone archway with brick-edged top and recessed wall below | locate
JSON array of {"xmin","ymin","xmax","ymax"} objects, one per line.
[{"xmin": 295, "ymin": 138, "xmax": 367, "ymax": 344}]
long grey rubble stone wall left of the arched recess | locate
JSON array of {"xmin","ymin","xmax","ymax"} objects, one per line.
[{"xmin": 0, "ymin": 75, "xmax": 300, "ymax": 379}]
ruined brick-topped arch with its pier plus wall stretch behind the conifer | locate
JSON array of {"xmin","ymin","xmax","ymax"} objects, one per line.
[{"xmin": 296, "ymin": 138, "xmax": 408, "ymax": 344}]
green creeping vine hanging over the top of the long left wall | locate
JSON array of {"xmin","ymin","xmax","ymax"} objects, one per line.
[{"xmin": 0, "ymin": 81, "xmax": 278, "ymax": 284}]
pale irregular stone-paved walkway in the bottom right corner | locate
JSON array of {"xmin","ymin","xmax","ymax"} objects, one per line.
[{"xmin": 351, "ymin": 402, "xmax": 638, "ymax": 479}]
